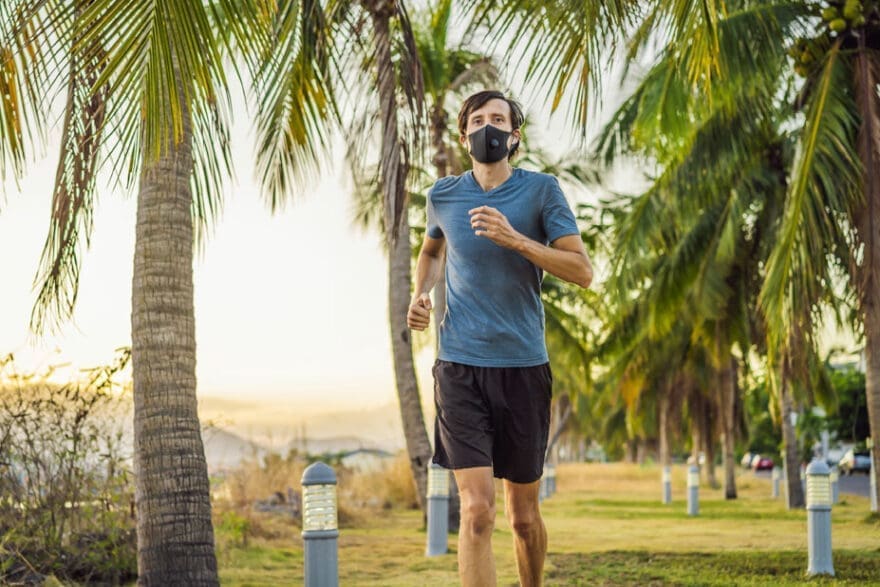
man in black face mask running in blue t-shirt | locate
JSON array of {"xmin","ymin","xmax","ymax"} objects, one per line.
[{"xmin": 407, "ymin": 91, "xmax": 593, "ymax": 587}]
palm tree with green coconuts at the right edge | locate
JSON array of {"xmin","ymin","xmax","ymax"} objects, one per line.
[{"xmin": 620, "ymin": 0, "xmax": 880, "ymax": 506}]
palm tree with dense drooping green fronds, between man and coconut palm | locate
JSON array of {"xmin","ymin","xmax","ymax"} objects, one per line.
[{"xmin": 584, "ymin": 38, "xmax": 796, "ymax": 498}]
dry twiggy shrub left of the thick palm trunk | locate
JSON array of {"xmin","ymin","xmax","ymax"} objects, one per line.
[{"xmin": 0, "ymin": 349, "xmax": 137, "ymax": 583}]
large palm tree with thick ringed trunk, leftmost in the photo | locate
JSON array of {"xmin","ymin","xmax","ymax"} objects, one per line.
[{"xmin": 12, "ymin": 0, "xmax": 336, "ymax": 585}]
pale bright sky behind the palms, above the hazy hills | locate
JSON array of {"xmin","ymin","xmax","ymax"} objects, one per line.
[{"xmin": 0, "ymin": 81, "xmax": 600, "ymax": 414}]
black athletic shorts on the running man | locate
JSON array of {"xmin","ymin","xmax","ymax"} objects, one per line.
[{"xmin": 433, "ymin": 360, "xmax": 553, "ymax": 483}]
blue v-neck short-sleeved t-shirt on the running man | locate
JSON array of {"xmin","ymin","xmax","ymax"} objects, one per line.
[{"xmin": 428, "ymin": 168, "xmax": 580, "ymax": 367}]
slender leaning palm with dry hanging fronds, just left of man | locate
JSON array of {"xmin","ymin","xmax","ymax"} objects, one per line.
[{"xmin": 334, "ymin": 0, "xmax": 432, "ymax": 512}]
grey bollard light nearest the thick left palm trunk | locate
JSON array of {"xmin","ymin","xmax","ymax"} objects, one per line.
[{"xmin": 302, "ymin": 463, "xmax": 339, "ymax": 587}]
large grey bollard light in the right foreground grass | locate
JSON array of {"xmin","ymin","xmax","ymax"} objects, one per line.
[{"xmin": 806, "ymin": 459, "xmax": 834, "ymax": 576}]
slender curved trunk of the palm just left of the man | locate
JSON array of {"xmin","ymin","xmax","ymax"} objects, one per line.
[{"xmin": 364, "ymin": 0, "xmax": 431, "ymax": 512}]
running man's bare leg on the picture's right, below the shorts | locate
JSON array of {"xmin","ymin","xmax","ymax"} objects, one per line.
[{"xmin": 504, "ymin": 479, "xmax": 547, "ymax": 587}]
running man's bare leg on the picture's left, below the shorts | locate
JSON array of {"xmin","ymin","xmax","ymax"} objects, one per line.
[{"xmin": 453, "ymin": 467, "xmax": 495, "ymax": 587}]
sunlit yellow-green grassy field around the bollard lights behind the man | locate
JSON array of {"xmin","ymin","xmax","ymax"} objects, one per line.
[{"xmin": 217, "ymin": 464, "xmax": 880, "ymax": 587}]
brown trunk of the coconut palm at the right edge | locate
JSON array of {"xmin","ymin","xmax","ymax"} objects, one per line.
[{"xmin": 854, "ymin": 35, "xmax": 880, "ymax": 510}]
